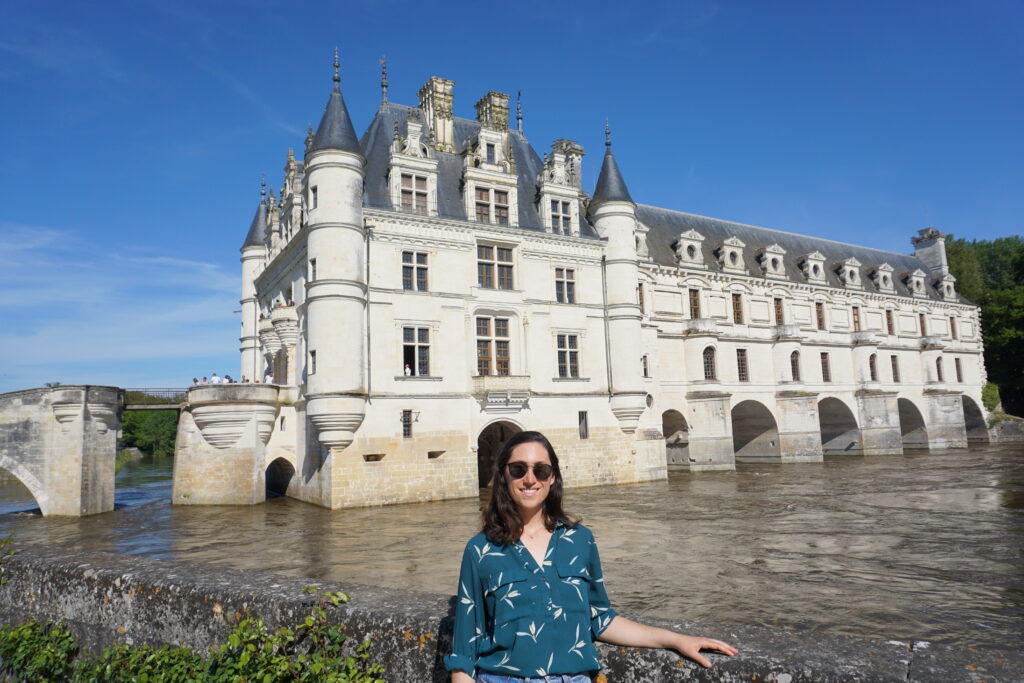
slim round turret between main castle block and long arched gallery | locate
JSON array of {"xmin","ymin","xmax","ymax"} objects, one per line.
[{"xmin": 589, "ymin": 124, "xmax": 646, "ymax": 433}]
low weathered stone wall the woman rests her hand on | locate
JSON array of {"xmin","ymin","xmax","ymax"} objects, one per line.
[{"xmin": 0, "ymin": 543, "xmax": 1024, "ymax": 683}]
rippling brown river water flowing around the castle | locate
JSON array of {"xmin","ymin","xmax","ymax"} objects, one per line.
[{"xmin": 0, "ymin": 445, "xmax": 1024, "ymax": 649}]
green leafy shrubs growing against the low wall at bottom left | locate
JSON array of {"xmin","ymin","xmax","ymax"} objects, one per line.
[{"xmin": 0, "ymin": 587, "xmax": 384, "ymax": 683}]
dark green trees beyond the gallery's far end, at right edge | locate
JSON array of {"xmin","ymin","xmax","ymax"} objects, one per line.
[{"xmin": 946, "ymin": 236, "xmax": 1024, "ymax": 415}]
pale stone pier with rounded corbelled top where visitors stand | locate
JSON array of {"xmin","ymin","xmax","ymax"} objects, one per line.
[{"xmin": 171, "ymin": 384, "xmax": 279, "ymax": 505}]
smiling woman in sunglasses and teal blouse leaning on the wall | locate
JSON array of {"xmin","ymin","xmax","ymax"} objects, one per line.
[{"xmin": 444, "ymin": 431, "xmax": 736, "ymax": 683}]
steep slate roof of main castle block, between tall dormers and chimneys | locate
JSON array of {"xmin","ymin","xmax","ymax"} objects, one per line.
[{"xmin": 361, "ymin": 102, "xmax": 597, "ymax": 238}]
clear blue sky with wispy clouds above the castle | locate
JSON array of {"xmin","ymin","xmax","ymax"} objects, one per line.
[{"xmin": 0, "ymin": 0, "xmax": 1024, "ymax": 391}]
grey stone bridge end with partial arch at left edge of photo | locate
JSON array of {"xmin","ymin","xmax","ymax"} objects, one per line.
[{"xmin": 0, "ymin": 386, "xmax": 124, "ymax": 517}]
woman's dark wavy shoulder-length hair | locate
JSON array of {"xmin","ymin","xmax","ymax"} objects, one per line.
[{"xmin": 483, "ymin": 431, "xmax": 580, "ymax": 545}]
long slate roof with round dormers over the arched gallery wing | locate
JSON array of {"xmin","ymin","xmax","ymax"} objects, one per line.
[{"xmin": 636, "ymin": 204, "xmax": 970, "ymax": 303}]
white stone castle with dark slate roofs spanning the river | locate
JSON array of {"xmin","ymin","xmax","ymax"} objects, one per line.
[{"xmin": 174, "ymin": 58, "xmax": 987, "ymax": 508}]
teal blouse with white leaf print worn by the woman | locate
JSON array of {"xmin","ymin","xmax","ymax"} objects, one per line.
[{"xmin": 444, "ymin": 524, "xmax": 616, "ymax": 677}]
